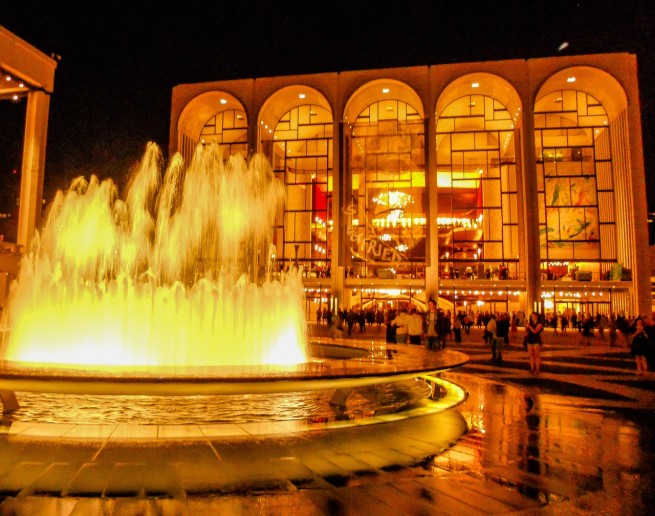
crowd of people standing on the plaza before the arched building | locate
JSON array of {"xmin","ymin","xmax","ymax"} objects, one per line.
[{"xmin": 316, "ymin": 299, "xmax": 655, "ymax": 375}]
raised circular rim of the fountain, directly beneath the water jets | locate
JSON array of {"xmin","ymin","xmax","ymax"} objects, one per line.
[{"xmin": 0, "ymin": 345, "xmax": 469, "ymax": 396}]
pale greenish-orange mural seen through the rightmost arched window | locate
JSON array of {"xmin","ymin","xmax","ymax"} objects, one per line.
[{"xmin": 545, "ymin": 176, "xmax": 599, "ymax": 247}]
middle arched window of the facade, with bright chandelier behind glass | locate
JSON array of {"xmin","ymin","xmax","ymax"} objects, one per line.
[{"xmin": 344, "ymin": 99, "xmax": 427, "ymax": 279}]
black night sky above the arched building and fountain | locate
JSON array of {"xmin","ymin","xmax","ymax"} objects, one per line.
[{"xmin": 0, "ymin": 0, "xmax": 655, "ymax": 224}]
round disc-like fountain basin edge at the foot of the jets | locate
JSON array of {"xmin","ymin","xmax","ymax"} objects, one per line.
[{"xmin": 0, "ymin": 340, "xmax": 469, "ymax": 410}]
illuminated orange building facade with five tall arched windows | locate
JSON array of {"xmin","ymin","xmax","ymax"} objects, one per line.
[{"xmin": 169, "ymin": 53, "xmax": 651, "ymax": 317}]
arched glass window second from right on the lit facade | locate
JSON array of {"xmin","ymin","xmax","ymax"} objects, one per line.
[{"xmin": 437, "ymin": 95, "xmax": 525, "ymax": 280}]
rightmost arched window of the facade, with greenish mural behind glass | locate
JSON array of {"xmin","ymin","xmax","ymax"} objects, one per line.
[{"xmin": 535, "ymin": 90, "xmax": 623, "ymax": 281}]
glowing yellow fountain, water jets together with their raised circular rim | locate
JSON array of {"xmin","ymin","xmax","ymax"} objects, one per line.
[{"xmin": 0, "ymin": 143, "xmax": 468, "ymax": 420}]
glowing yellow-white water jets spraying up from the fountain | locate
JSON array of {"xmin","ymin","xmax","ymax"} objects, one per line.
[{"xmin": 0, "ymin": 143, "xmax": 307, "ymax": 375}]
